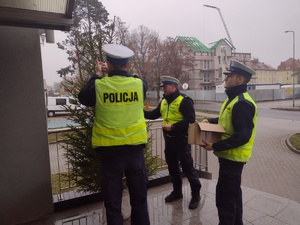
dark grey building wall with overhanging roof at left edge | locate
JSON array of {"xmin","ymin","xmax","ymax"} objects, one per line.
[{"xmin": 0, "ymin": 0, "xmax": 74, "ymax": 224}]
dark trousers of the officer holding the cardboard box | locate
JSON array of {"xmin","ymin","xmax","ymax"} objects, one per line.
[{"xmin": 216, "ymin": 158, "xmax": 245, "ymax": 225}]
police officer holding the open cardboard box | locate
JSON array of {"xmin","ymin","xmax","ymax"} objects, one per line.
[{"xmin": 203, "ymin": 61, "xmax": 257, "ymax": 225}]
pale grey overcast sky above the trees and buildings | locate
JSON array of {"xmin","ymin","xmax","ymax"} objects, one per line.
[{"xmin": 41, "ymin": 0, "xmax": 300, "ymax": 85}]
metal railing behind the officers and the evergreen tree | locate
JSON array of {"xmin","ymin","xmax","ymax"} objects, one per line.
[{"xmin": 48, "ymin": 119, "xmax": 208, "ymax": 201}]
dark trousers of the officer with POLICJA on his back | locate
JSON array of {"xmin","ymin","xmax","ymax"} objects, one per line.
[{"xmin": 96, "ymin": 145, "xmax": 150, "ymax": 225}]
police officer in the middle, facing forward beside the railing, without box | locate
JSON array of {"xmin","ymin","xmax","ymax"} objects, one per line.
[{"xmin": 144, "ymin": 76, "xmax": 201, "ymax": 209}]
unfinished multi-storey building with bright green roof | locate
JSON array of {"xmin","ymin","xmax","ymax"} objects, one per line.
[{"xmin": 176, "ymin": 36, "xmax": 251, "ymax": 90}]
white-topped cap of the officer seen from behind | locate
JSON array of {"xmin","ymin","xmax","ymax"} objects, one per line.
[{"xmin": 102, "ymin": 44, "xmax": 134, "ymax": 63}]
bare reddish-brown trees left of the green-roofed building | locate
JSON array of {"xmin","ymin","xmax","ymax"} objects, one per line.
[{"xmin": 128, "ymin": 29, "xmax": 194, "ymax": 98}]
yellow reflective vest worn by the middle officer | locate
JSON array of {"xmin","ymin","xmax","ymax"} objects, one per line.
[{"xmin": 160, "ymin": 95, "xmax": 184, "ymax": 125}]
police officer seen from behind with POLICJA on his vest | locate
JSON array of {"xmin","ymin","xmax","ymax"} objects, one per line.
[{"xmin": 78, "ymin": 44, "xmax": 150, "ymax": 225}]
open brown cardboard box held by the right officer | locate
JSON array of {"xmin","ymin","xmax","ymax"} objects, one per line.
[{"xmin": 188, "ymin": 122, "xmax": 225, "ymax": 145}]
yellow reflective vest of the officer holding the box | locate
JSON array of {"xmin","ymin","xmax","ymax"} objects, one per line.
[{"xmin": 214, "ymin": 92, "xmax": 257, "ymax": 162}]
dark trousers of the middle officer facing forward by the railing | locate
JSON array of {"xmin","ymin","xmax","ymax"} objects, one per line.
[{"xmin": 164, "ymin": 133, "xmax": 201, "ymax": 198}]
